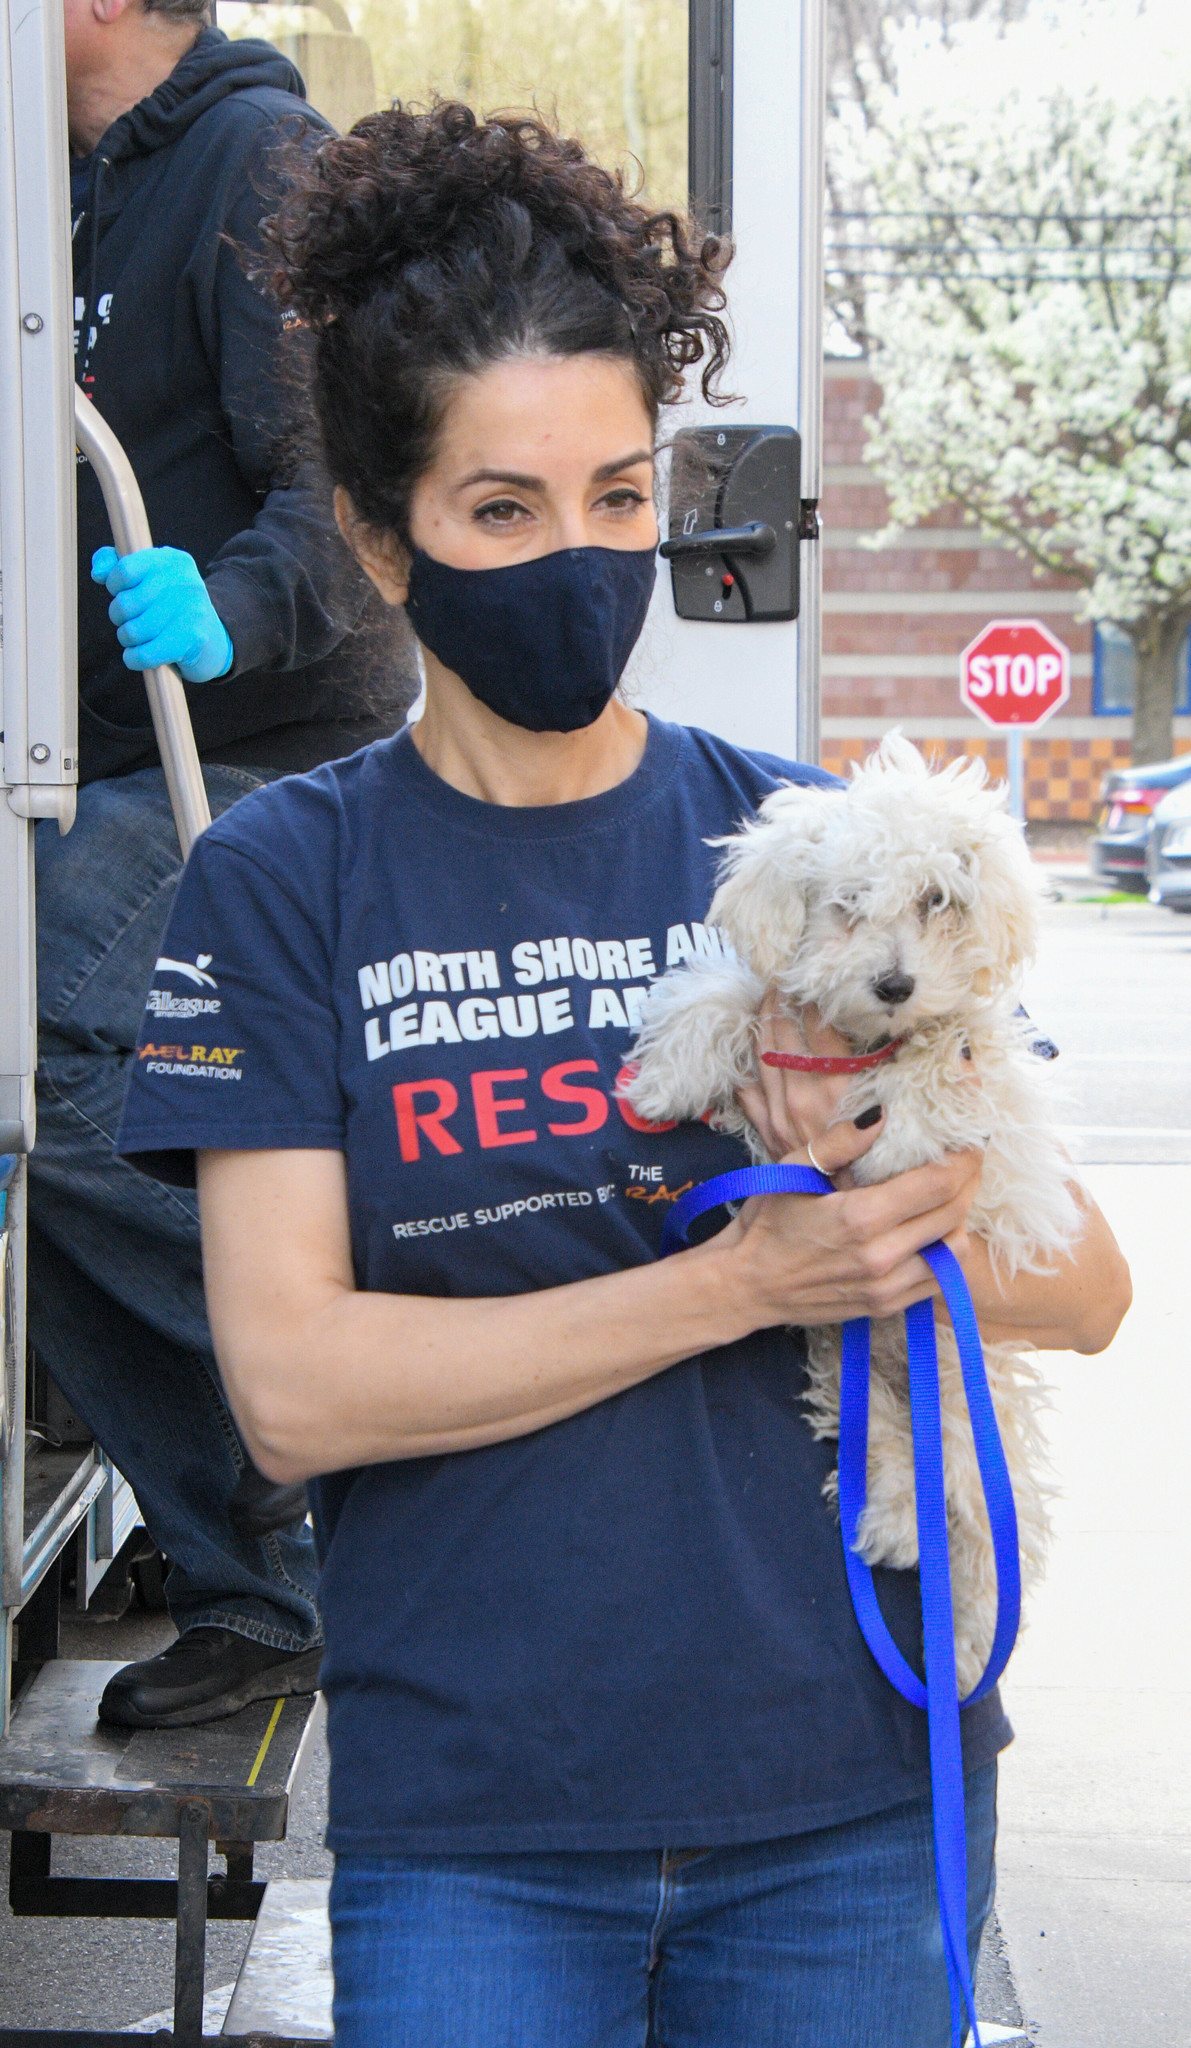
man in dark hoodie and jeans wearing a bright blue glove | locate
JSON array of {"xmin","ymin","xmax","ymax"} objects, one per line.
[{"xmin": 29, "ymin": 0, "xmax": 415, "ymax": 1726}]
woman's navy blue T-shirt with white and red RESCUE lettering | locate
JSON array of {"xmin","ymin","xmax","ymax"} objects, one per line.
[{"xmin": 119, "ymin": 721, "xmax": 1009, "ymax": 1853}]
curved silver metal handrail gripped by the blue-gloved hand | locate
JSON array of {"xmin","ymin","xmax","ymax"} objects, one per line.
[{"xmin": 74, "ymin": 385, "xmax": 211, "ymax": 856}]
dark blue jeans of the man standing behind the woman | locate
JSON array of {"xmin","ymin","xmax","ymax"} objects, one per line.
[{"xmin": 29, "ymin": 768, "xmax": 321, "ymax": 1651}]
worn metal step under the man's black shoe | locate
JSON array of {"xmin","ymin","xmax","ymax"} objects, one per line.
[{"xmin": 0, "ymin": 1659, "xmax": 317, "ymax": 1841}]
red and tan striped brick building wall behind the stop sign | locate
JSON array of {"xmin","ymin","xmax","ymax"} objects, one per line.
[{"xmin": 823, "ymin": 358, "xmax": 1191, "ymax": 821}]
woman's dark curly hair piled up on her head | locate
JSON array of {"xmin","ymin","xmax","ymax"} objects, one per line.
[{"xmin": 264, "ymin": 100, "xmax": 731, "ymax": 545}]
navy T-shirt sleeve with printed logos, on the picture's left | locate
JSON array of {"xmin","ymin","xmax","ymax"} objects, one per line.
[{"xmin": 117, "ymin": 834, "xmax": 344, "ymax": 1186}]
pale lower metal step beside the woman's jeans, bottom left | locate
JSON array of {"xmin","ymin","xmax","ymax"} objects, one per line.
[{"xmin": 223, "ymin": 1878, "xmax": 334, "ymax": 2042}]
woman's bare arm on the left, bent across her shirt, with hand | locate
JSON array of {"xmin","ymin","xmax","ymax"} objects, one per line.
[{"xmin": 199, "ymin": 1151, "xmax": 990, "ymax": 1481}]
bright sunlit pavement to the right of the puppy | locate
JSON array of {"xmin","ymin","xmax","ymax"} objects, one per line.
[{"xmin": 997, "ymin": 870, "xmax": 1191, "ymax": 2048}]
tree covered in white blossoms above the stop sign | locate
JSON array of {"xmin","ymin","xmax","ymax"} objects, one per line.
[{"xmin": 866, "ymin": 84, "xmax": 1191, "ymax": 762}]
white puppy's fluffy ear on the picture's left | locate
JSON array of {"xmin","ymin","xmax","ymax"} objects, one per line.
[{"xmin": 708, "ymin": 784, "xmax": 843, "ymax": 983}]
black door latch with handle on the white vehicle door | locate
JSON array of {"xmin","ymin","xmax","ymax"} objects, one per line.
[{"xmin": 661, "ymin": 426, "xmax": 802, "ymax": 625}]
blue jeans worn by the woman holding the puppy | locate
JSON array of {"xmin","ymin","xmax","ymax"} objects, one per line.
[{"xmin": 332, "ymin": 1763, "xmax": 997, "ymax": 2048}]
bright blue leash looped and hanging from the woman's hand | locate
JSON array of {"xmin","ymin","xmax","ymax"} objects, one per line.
[{"xmin": 661, "ymin": 1165, "xmax": 1021, "ymax": 2048}]
